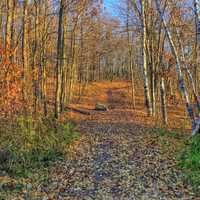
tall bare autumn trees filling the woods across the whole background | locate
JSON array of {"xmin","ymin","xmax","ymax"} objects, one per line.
[{"xmin": 0, "ymin": 0, "xmax": 200, "ymax": 134}]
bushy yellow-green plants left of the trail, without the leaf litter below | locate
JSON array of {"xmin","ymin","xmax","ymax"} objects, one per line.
[{"xmin": 0, "ymin": 117, "xmax": 79, "ymax": 177}]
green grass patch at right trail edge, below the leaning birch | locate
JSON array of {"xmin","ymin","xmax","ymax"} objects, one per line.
[{"xmin": 152, "ymin": 128, "xmax": 200, "ymax": 194}]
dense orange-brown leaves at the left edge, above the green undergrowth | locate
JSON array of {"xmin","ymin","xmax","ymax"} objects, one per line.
[{"xmin": 0, "ymin": 48, "xmax": 22, "ymax": 117}]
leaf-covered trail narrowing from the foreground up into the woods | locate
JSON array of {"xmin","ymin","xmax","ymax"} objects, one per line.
[{"xmin": 36, "ymin": 85, "xmax": 195, "ymax": 200}]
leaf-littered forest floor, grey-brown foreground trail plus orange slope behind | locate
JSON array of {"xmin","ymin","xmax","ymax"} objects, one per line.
[{"xmin": 0, "ymin": 82, "xmax": 200, "ymax": 200}]
